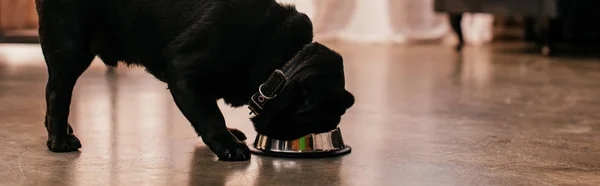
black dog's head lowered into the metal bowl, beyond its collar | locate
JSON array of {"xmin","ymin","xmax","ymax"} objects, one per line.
[{"xmin": 252, "ymin": 43, "xmax": 354, "ymax": 140}]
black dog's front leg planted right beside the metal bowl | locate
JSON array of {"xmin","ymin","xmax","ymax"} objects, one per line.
[{"xmin": 169, "ymin": 78, "xmax": 250, "ymax": 161}]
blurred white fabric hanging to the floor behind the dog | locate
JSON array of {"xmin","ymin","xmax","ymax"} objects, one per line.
[{"xmin": 278, "ymin": 0, "xmax": 493, "ymax": 44}]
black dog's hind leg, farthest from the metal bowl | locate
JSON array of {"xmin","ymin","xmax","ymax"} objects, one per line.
[{"xmin": 37, "ymin": 1, "xmax": 94, "ymax": 152}]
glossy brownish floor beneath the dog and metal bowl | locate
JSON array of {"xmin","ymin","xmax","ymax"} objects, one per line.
[{"xmin": 0, "ymin": 43, "xmax": 600, "ymax": 186}]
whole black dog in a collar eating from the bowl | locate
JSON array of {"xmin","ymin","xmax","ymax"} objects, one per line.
[{"xmin": 36, "ymin": 0, "xmax": 354, "ymax": 161}]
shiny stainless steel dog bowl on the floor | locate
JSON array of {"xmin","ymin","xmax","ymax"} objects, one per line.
[{"xmin": 250, "ymin": 128, "xmax": 352, "ymax": 158}]
